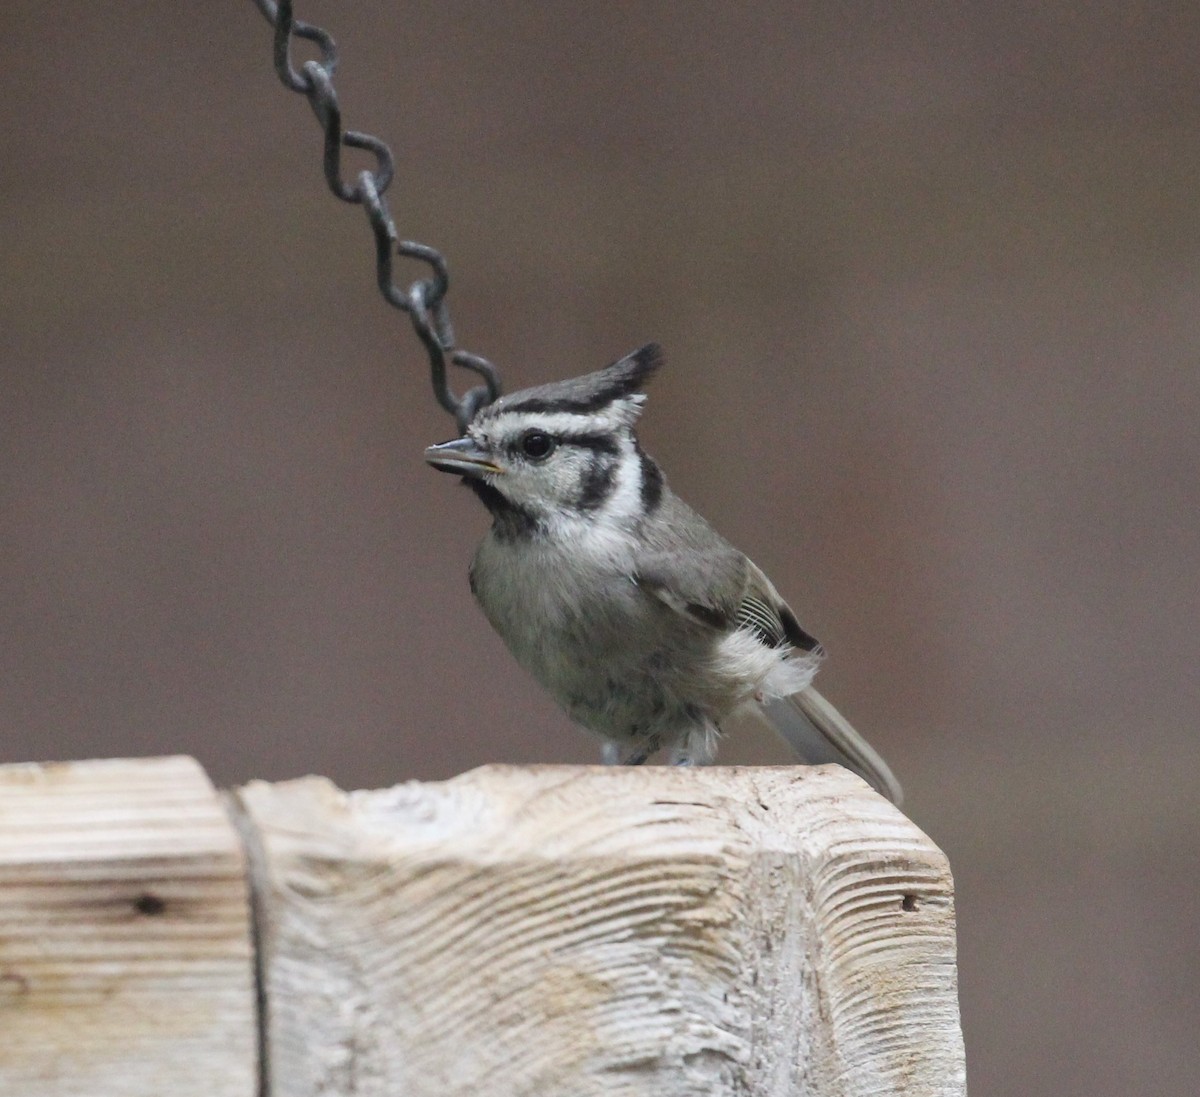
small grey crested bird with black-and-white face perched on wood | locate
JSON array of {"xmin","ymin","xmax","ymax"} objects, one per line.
[{"xmin": 425, "ymin": 343, "xmax": 901, "ymax": 804}]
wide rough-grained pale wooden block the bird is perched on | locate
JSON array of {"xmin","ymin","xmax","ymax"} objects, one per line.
[{"xmin": 240, "ymin": 766, "xmax": 965, "ymax": 1097}]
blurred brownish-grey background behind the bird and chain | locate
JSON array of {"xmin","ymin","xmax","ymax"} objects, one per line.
[{"xmin": 0, "ymin": 0, "xmax": 1200, "ymax": 1097}]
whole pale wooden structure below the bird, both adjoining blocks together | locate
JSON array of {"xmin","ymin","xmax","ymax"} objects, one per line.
[{"xmin": 0, "ymin": 759, "xmax": 965, "ymax": 1097}]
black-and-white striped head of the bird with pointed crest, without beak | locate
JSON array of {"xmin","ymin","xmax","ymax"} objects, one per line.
[{"xmin": 467, "ymin": 343, "xmax": 662, "ymax": 535}]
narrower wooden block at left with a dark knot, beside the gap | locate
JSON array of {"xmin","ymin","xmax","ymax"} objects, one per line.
[{"xmin": 0, "ymin": 757, "xmax": 257, "ymax": 1097}]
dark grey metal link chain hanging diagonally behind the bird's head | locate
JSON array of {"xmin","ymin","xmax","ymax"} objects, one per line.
[{"xmin": 254, "ymin": 0, "xmax": 500, "ymax": 431}]
